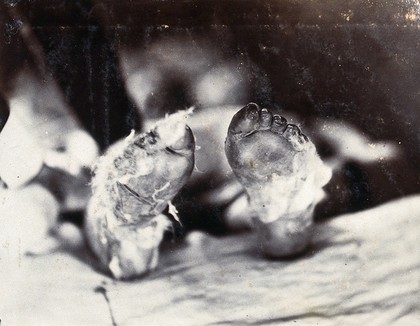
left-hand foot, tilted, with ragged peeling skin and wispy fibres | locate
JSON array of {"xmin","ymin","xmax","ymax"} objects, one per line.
[{"xmin": 86, "ymin": 112, "xmax": 195, "ymax": 278}]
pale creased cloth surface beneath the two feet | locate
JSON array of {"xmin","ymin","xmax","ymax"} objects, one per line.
[{"xmin": 0, "ymin": 196, "xmax": 420, "ymax": 325}]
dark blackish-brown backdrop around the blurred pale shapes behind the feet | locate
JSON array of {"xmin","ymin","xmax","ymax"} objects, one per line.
[{"xmin": 1, "ymin": 0, "xmax": 420, "ymax": 229}]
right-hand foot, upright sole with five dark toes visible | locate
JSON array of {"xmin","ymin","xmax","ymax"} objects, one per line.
[{"xmin": 225, "ymin": 103, "xmax": 331, "ymax": 257}]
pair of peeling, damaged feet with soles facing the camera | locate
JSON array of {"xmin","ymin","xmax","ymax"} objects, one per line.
[{"xmin": 86, "ymin": 103, "xmax": 331, "ymax": 278}]
